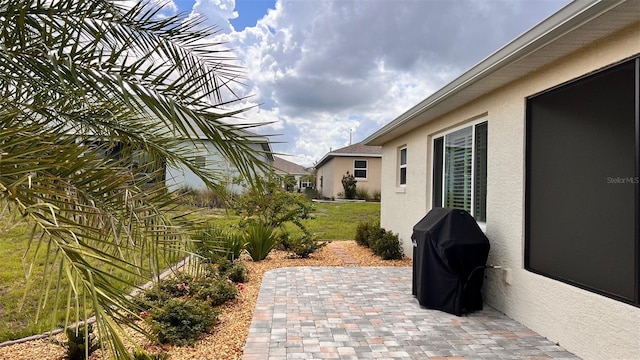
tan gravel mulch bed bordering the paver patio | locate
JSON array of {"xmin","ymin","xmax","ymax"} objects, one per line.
[{"xmin": 0, "ymin": 241, "xmax": 411, "ymax": 360}]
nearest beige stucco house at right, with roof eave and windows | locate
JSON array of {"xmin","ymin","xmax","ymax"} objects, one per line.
[{"xmin": 364, "ymin": 0, "xmax": 640, "ymax": 359}]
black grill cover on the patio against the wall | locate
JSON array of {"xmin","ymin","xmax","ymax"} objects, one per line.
[{"xmin": 411, "ymin": 208, "xmax": 489, "ymax": 316}]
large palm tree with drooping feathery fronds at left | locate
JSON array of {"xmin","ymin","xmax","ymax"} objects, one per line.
[{"xmin": 0, "ymin": 0, "xmax": 263, "ymax": 358}]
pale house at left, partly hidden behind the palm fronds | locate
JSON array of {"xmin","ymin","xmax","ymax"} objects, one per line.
[{"xmin": 166, "ymin": 130, "xmax": 274, "ymax": 193}]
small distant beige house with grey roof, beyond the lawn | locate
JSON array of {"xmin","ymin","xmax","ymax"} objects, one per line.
[{"xmin": 315, "ymin": 143, "xmax": 382, "ymax": 198}]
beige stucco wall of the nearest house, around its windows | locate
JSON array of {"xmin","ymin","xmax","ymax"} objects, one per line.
[{"xmin": 381, "ymin": 23, "xmax": 640, "ymax": 359}]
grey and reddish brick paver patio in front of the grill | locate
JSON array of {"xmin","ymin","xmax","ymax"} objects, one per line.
[{"xmin": 242, "ymin": 267, "xmax": 578, "ymax": 360}]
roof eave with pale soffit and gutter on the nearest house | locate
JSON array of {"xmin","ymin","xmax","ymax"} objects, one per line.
[{"xmin": 363, "ymin": 0, "xmax": 640, "ymax": 145}]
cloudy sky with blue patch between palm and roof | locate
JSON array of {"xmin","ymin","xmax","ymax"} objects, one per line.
[{"xmin": 160, "ymin": 0, "xmax": 570, "ymax": 166}]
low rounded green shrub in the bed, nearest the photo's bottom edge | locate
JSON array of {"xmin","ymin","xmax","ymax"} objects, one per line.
[{"xmin": 150, "ymin": 299, "xmax": 218, "ymax": 345}]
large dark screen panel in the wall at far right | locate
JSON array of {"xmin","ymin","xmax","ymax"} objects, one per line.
[{"xmin": 525, "ymin": 60, "xmax": 640, "ymax": 304}]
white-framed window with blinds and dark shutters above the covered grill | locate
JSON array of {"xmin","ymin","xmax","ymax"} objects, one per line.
[{"xmin": 433, "ymin": 121, "xmax": 487, "ymax": 222}]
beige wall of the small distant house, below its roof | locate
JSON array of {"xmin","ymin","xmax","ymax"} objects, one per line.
[{"xmin": 316, "ymin": 156, "xmax": 382, "ymax": 198}]
